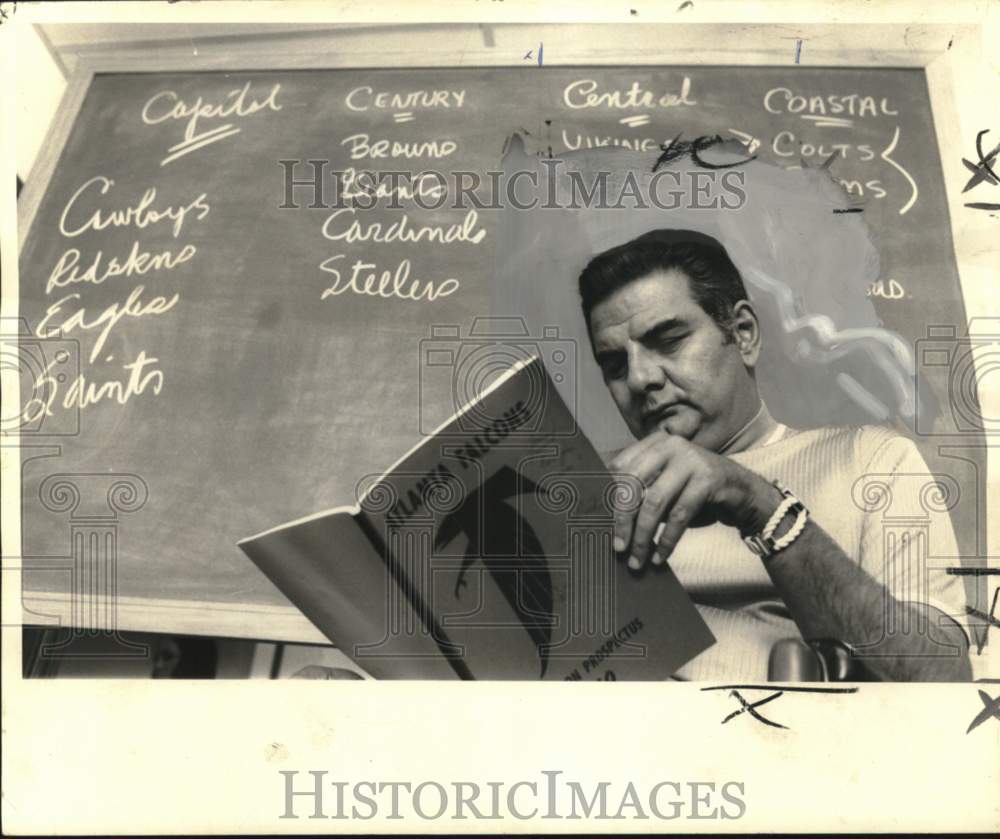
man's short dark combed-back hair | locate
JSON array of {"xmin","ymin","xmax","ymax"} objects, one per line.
[{"xmin": 580, "ymin": 229, "xmax": 747, "ymax": 341}]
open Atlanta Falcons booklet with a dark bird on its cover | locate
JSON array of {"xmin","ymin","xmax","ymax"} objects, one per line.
[{"xmin": 239, "ymin": 357, "xmax": 715, "ymax": 681}]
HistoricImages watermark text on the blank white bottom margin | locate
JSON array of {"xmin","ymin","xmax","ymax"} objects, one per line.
[{"xmin": 278, "ymin": 769, "xmax": 747, "ymax": 821}]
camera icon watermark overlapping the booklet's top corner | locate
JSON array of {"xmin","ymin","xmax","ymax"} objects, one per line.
[{"xmin": 419, "ymin": 317, "xmax": 577, "ymax": 436}]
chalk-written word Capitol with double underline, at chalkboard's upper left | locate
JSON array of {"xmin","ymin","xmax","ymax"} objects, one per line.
[{"xmin": 142, "ymin": 82, "xmax": 281, "ymax": 166}]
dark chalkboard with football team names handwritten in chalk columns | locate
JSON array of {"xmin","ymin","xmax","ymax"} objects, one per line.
[{"xmin": 20, "ymin": 67, "xmax": 985, "ymax": 636}]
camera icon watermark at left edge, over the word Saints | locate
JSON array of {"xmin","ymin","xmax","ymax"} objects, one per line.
[{"xmin": 0, "ymin": 318, "xmax": 80, "ymax": 437}]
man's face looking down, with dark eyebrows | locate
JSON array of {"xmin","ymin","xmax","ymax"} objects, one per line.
[{"xmin": 590, "ymin": 270, "xmax": 757, "ymax": 451}]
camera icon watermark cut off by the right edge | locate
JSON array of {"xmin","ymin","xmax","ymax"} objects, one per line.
[{"xmin": 915, "ymin": 318, "xmax": 1000, "ymax": 437}]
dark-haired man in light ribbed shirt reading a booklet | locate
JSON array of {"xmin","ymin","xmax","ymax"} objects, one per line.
[{"xmin": 579, "ymin": 230, "xmax": 971, "ymax": 681}]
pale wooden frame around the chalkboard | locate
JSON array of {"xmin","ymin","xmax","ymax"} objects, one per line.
[{"xmin": 18, "ymin": 24, "xmax": 1000, "ymax": 643}]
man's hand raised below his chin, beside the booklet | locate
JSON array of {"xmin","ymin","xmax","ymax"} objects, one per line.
[{"xmin": 608, "ymin": 431, "xmax": 782, "ymax": 570}]
